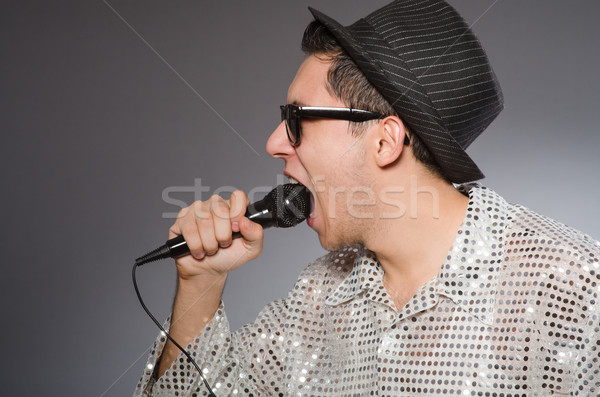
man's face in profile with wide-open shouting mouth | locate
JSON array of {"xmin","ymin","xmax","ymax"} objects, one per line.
[{"xmin": 267, "ymin": 56, "xmax": 369, "ymax": 250}]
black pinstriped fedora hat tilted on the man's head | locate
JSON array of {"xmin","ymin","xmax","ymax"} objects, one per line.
[{"xmin": 309, "ymin": 0, "xmax": 503, "ymax": 183}]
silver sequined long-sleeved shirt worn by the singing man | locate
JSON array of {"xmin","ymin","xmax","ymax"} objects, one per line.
[{"xmin": 135, "ymin": 184, "xmax": 600, "ymax": 397}]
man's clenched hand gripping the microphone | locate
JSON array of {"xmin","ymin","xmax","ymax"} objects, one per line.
[{"xmin": 169, "ymin": 190, "xmax": 263, "ymax": 280}]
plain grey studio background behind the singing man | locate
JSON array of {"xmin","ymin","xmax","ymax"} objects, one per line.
[{"xmin": 0, "ymin": 0, "xmax": 600, "ymax": 397}]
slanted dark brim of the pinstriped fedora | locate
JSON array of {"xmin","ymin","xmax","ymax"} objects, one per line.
[{"xmin": 308, "ymin": 7, "xmax": 484, "ymax": 183}]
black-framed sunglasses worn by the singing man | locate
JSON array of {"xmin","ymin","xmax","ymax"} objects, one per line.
[{"xmin": 279, "ymin": 104, "xmax": 390, "ymax": 146}]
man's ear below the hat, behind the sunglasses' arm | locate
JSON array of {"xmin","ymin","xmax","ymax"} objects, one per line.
[{"xmin": 372, "ymin": 116, "xmax": 406, "ymax": 168}]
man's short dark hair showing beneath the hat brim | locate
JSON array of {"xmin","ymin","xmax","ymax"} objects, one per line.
[{"xmin": 302, "ymin": 21, "xmax": 448, "ymax": 181}]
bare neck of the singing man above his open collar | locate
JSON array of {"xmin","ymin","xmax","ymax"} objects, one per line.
[{"xmin": 364, "ymin": 173, "xmax": 469, "ymax": 296}]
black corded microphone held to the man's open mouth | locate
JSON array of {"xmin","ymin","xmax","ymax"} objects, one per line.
[{"xmin": 135, "ymin": 183, "xmax": 310, "ymax": 266}]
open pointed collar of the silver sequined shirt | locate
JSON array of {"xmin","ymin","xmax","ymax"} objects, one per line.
[{"xmin": 326, "ymin": 183, "xmax": 509, "ymax": 325}]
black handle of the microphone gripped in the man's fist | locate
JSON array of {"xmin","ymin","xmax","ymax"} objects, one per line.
[{"xmin": 135, "ymin": 199, "xmax": 276, "ymax": 265}]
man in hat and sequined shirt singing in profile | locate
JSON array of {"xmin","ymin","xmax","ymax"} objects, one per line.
[{"xmin": 136, "ymin": 0, "xmax": 600, "ymax": 396}]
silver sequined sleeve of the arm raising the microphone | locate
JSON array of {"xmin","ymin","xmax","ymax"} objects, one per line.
[{"xmin": 134, "ymin": 251, "xmax": 346, "ymax": 397}]
